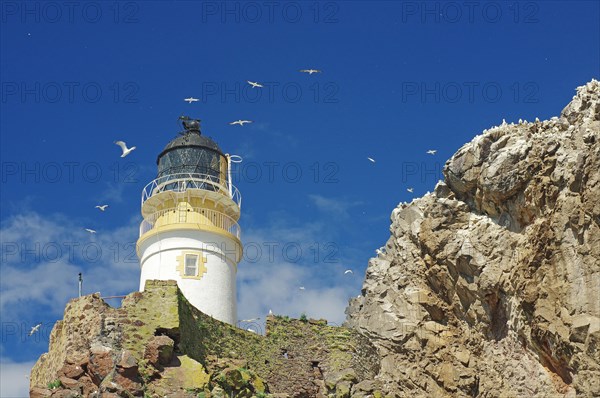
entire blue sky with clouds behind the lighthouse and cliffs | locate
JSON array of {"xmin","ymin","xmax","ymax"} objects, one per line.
[{"xmin": 0, "ymin": 1, "xmax": 600, "ymax": 397}]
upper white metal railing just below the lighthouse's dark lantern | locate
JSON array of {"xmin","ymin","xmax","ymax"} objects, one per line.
[{"xmin": 142, "ymin": 173, "xmax": 242, "ymax": 209}]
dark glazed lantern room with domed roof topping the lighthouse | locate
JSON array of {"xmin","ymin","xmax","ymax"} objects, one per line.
[{"xmin": 156, "ymin": 118, "xmax": 227, "ymax": 178}]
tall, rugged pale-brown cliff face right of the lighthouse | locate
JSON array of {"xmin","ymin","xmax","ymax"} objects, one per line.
[{"xmin": 347, "ymin": 81, "xmax": 600, "ymax": 397}]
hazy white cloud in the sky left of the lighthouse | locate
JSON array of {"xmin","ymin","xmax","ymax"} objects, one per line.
[{"xmin": 0, "ymin": 212, "xmax": 139, "ymax": 322}]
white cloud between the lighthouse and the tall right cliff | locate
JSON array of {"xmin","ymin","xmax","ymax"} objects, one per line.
[{"xmin": 238, "ymin": 207, "xmax": 362, "ymax": 325}]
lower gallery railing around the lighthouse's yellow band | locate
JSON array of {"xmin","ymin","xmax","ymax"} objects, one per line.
[{"xmin": 140, "ymin": 207, "xmax": 241, "ymax": 239}]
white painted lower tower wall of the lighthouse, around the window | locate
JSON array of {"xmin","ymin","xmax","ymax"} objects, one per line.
[{"xmin": 139, "ymin": 229, "xmax": 240, "ymax": 325}]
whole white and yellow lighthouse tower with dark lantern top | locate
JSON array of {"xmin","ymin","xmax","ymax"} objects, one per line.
[{"xmin": 136, "ymin": 116, "xmax": 242, "ymax": 324}]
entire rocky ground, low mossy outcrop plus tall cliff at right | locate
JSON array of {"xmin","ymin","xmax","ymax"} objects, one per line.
[{"xmin": 31, "ymin": 81, "xmax": 600, "ymax": 398}]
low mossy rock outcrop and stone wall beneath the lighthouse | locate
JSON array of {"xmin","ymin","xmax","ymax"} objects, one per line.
[{"xmin": 30, "ymin": 281, "xmax": 378, "ymax": 398}]
